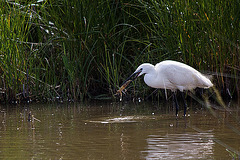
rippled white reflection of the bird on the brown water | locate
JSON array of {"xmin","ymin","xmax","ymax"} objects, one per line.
[{"xmin": 143, "ymin": 133, "xmax": 214, "ymax": 159}]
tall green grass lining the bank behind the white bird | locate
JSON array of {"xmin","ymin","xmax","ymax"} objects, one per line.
[{"xmin": 0, "ymin": 0, "xmax": 240, "ymax": 102}]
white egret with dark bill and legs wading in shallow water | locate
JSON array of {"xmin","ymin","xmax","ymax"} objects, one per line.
[{"xmin": 123, "ymin": 60, "xmax": 213, "ymax": 116}]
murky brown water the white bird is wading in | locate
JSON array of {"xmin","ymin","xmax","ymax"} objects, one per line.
[{"xmin": 0, "ymin": 103, "xmax": 240, "ymax": 160}]
